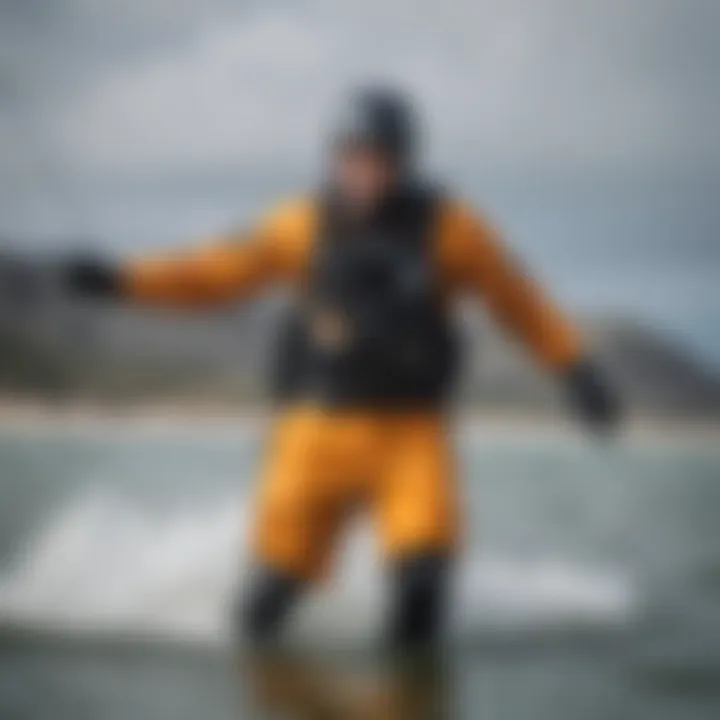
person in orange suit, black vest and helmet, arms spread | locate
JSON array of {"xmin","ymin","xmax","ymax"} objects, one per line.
[{"xmin": 66, "ymin": 87, "xmax": 619, "ymax": 647}]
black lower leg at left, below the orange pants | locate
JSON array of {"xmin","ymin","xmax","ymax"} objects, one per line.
[{"xmin": 238, "ymin": 567, "xmax": 303, "ymax": 642}]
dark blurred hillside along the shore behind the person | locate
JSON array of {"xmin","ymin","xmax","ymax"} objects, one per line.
[{"xmin": 0, "ymin": 256, "xmax": 720, "ymax": 418}]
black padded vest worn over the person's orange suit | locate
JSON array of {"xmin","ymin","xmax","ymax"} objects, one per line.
[{"xmin": 273, "ymin": 187, "xmax": 458, "ymax": 409}]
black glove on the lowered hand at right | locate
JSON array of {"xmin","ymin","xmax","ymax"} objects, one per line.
[{"xmin": 564, "ymin": 360, "xmax": 622, "ymax": 432}]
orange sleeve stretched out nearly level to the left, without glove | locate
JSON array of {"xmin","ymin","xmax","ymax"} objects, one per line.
[{"xmin": 120, "ymin": 202, "xmax": 313, "ymax": 308}]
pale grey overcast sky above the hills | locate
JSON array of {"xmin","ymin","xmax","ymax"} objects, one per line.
[{"xmin": 0, "ymin": 0, "xmax": 720, "ymax": 366}]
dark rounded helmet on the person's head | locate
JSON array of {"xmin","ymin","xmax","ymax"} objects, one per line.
[{"xmin": 333, "ymin": 87, "xmax": 417, "ymax": 164}]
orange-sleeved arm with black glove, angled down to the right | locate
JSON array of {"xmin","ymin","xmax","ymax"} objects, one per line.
[{"xmin": 440, "ymin": 204, "xmax": 619, "ymax": 426}]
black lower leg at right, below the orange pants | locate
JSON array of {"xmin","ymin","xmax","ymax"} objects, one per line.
[{"xmin": 389, "ymin": 553, "xmax": 450, "ymax": 649}]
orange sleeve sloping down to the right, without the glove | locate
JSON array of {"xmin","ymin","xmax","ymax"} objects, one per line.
[{"xmin": 440, "ymin": 203, "xmax": 582, "ymax": 370}]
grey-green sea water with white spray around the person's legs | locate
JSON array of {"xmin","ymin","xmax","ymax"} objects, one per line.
[{"xmin": 0, "ymin": 425, "xmax": 720, "ymax": 720}]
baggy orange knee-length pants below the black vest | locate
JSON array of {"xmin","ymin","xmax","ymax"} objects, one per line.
[{"xmin": 254, "ymin": 407, "xmax": 458, "ymax": 579}]
